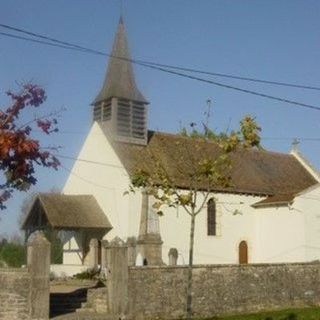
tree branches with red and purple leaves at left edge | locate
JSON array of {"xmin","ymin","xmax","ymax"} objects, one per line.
[{"xmin": 0, "ymin": 84, "xmax": 60, "ymax": 209}]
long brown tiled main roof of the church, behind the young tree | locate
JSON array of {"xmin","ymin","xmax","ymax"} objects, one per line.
[{"xmin": 110, "ymin": 132, "xmax": 317, "ymax": 195}]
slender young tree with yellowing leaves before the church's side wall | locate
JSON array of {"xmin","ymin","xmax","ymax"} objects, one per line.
[{"xmin": 130, "ymin": 116, "xmax": 261, "ymax": 319}]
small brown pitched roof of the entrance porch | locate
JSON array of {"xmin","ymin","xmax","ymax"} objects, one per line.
[{"xmin": 22, "ymin": 193, "xmax": 112, "ymax": 230}]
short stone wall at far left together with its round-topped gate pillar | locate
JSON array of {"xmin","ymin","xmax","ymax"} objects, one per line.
[{"xmin": 0, "ymin": 233, "xmax": 50, "ymax": 320}]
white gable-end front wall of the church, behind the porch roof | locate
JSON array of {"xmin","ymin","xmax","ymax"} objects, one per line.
[{"xmin": 63, "ymin": 123, "xmax": 140, "ymax": 240}]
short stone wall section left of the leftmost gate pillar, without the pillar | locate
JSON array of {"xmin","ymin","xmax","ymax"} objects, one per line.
[{"xmin": 0, "ymin": 269, "xmax": 31, "ymax": 320}]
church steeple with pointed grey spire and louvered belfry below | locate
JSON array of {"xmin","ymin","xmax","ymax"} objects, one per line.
[{"xmin": 92, "ymin": 18, "xmax": 148, "ymax": 144}]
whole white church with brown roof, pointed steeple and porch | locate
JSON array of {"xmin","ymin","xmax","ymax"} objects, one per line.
[{"xmin": 23, "ymin": 19, "xmax": 320, "ymax": 273}]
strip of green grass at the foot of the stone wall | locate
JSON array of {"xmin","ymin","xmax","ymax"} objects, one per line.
[{"xmin": 212, "ymin": 307, "xmax": 320, "ymax": 320}]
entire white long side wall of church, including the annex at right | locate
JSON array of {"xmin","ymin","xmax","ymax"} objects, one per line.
[{"xmin": 160, "ymin": 194, "xmax": 312, "ymax": 264}]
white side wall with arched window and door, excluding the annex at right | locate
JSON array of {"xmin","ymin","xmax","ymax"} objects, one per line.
[{"xmin": 160, "ymin": 194, "xmax": 259, "ymax": 264}]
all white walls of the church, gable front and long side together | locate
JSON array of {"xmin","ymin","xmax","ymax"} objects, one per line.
[{"xmin": 63, "ymin": 123, "xmax": 320, "ymax": 263}]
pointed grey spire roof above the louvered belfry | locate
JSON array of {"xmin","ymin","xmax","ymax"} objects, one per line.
[{"xmin": 93, "ymin": 18, "xmax": 148, "ymax": 105}]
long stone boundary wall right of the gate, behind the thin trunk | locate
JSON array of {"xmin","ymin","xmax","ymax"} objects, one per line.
[{"xmin": 128, "ymin": 263, "xmax": 320, "ymax": 320}]
